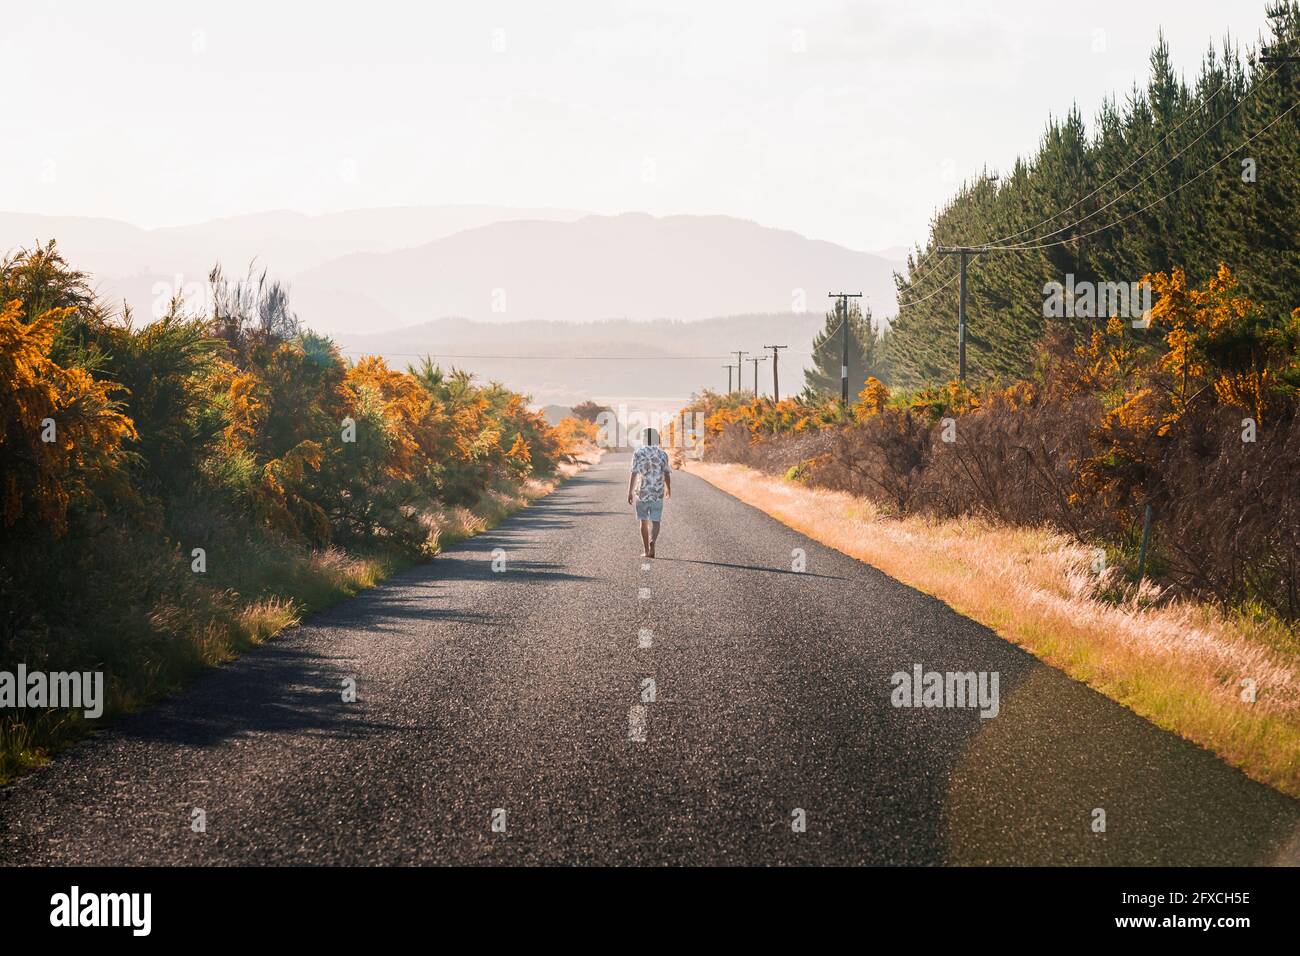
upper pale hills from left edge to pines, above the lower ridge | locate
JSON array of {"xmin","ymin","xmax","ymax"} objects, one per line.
[{"xmin": 0, "ymin": 206, "xmax": 900, "ymax": 345}]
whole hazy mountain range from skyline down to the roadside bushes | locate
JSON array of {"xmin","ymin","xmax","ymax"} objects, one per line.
[{"xmin": 0, "ymin": 206, "xmax": 901, "ymax": 403}]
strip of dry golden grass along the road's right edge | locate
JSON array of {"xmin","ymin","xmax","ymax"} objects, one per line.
[{"xmin": 686, "ymin": 462, "xmax": 1300, "ymax": 796}]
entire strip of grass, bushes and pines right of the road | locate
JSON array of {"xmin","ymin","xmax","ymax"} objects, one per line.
[{"xmin": 686, "ymin": 0, "xmax": 1300, "ymax": 796}]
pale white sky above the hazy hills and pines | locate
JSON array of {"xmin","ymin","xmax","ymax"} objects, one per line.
[{"xmin": 0, "ymin": 0, "xmax": 1265, "ymax": 250}]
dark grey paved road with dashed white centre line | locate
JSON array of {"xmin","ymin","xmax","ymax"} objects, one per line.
[{"xmin": 0, "ymin": 455, "xmax": 1300, "ymax": 864}]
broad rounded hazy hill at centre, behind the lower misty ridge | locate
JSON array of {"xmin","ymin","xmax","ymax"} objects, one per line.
[{"xmin": 294, "ymin": 213, "xmax": 897, "ymax": 329}]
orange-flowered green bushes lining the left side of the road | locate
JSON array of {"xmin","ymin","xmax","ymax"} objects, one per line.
[{"xmin": 0, "ymin": 243, "xmax": 594, "ymax": 782}]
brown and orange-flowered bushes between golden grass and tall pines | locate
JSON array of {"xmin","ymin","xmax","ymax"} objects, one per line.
[{"xmin": 689, "ymin": 267, "xmax": 1300, "ymax": 623}]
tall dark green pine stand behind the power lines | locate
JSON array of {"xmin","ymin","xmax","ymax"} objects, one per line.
[{"xmin": 883, "ymin": 0, "xmax": 1300, "ymax": 389}]
